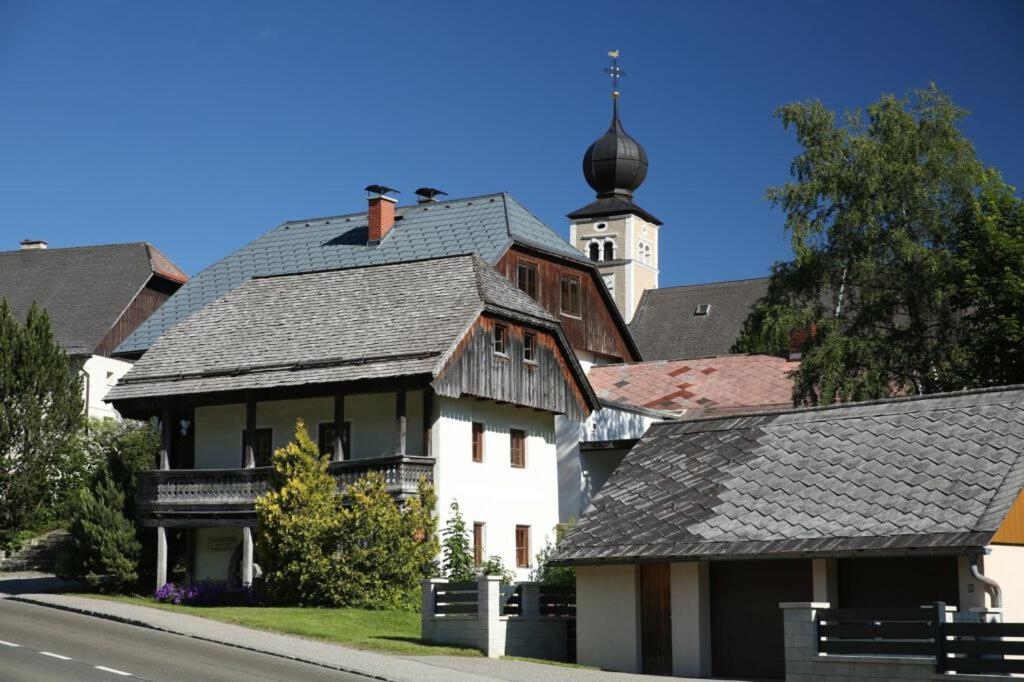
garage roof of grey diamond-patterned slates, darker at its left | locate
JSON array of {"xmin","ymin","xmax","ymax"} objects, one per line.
[{"xmin": 557, "ymin": 387, "xmax": 1024, "ymax": 563}]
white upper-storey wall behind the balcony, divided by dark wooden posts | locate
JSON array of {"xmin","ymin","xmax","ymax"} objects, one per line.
[{"xmin": 196, "ymin": 391, "xmax": 423, "ymax": 469}]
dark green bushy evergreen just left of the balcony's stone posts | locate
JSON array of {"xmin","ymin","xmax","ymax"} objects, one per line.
[{"xmin": 57, "ymin": 420, "xmax": 160, "ymax": 589}]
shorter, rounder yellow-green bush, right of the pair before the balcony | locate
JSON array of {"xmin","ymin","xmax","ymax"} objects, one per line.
[{"xmin": 339, "ymin": 471, "xmax": 437, "ymax": 609}]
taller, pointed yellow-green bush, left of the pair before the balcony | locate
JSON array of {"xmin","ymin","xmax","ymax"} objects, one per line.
[{"xmin": 256, "ymin": 420, "xmax": 344, "ymax": 606}]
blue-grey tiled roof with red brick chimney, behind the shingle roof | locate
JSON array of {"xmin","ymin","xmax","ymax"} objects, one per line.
[{"xmin": 118, "ymin": 194, "xmax": 589, "ymax": 353}]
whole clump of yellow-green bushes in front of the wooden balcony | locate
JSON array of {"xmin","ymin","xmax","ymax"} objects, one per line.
[{"xmin": 256, "ymin": 420, "xmax": 438, "ymax": 608}]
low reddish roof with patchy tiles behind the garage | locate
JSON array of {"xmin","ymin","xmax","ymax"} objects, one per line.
[{"xmin": 587, "ymin": 355, "xmax": 800, "ymax": 419}]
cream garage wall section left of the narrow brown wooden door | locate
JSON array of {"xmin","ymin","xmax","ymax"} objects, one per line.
[{"xmin": 577, "ymin": 565, "xmax": 640, "ymax": 673}]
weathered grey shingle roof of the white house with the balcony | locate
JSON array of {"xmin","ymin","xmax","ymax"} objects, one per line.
[{"xmin": 106, "ymin": 256, "xmax": 561, "ymax": 400}]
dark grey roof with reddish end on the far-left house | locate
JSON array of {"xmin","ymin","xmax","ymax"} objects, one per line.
[{"xmin": 0, "ymin": 242, "xmax": 188, "ymax": 355}]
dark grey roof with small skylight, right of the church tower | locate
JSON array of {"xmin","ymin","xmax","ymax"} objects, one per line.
[{"xmin": 630, "ymin": 278, "xmax": 768, "ymax": 360}]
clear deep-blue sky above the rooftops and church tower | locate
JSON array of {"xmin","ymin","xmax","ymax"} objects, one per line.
[{"xmin": 0, "ymin": 0, "xmax": 1024, "ymax": 286}]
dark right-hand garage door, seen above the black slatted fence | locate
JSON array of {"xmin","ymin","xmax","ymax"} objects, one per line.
[{"xmin": 836, "ymin": 556, "xmax": 959, "ymax": 608}]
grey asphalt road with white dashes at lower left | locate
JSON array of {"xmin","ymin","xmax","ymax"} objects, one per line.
[{"xmin": 0, "ymin": 599, "xmax": 369, "ymax": 682}]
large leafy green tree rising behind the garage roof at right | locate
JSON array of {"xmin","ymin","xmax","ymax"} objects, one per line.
[{"xmin": 734, "ymin": 85, "xmax": 1024, "ymax": 403}]
